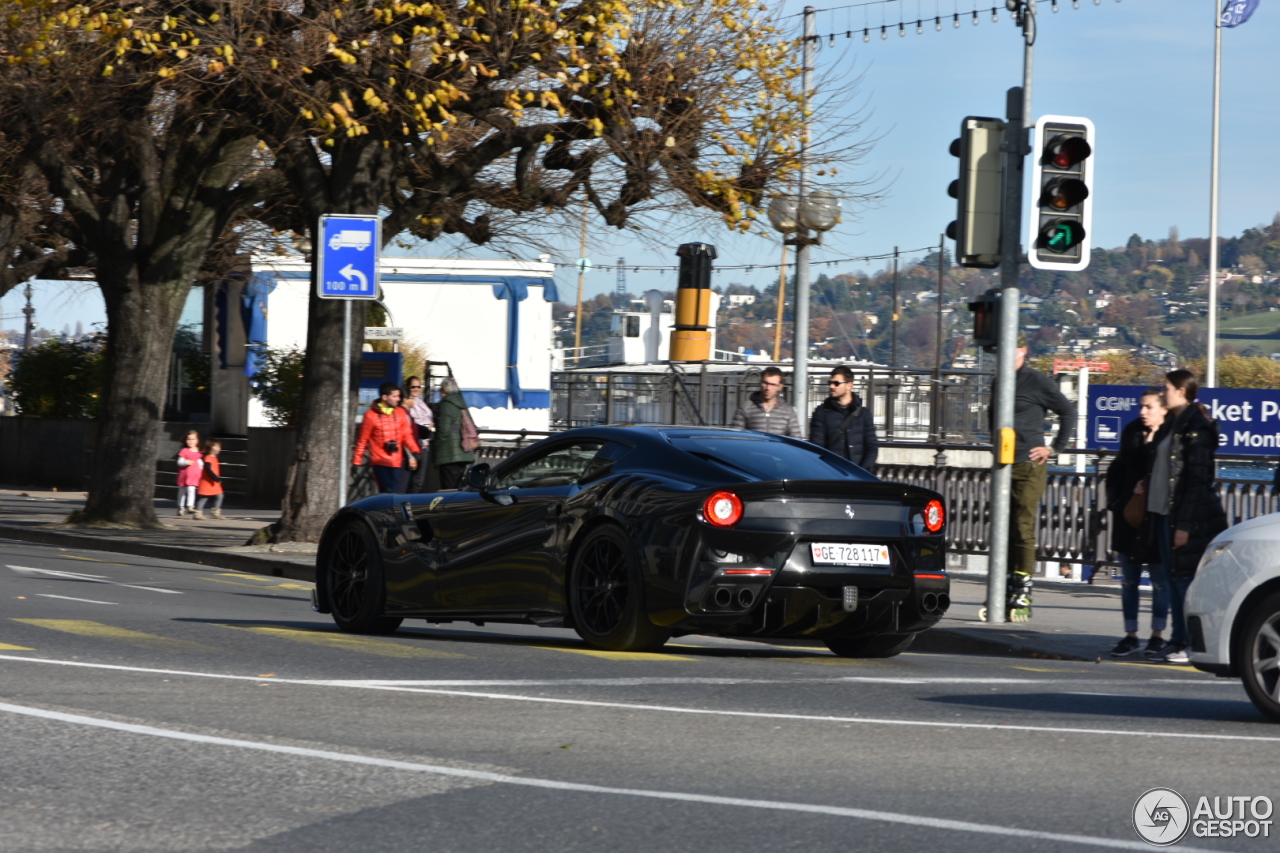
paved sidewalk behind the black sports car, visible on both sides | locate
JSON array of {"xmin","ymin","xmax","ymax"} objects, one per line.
[{"xmin": 0, "ymin": 487, "xmax": 1149, "ymax": 661}]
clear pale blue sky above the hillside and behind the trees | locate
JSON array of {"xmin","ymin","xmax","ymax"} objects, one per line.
[{"xmin": 0, "ymin": 0, "xmax": 1280, "ymax": 330}]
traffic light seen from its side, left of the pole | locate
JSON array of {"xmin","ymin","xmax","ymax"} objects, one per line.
[{"xmin": 947, "ymin": 115, "xmax": 1006, "ymax": 269}]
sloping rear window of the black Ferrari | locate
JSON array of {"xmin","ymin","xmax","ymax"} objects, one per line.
[{"xmin": 668, "ymin": 433, "xmax": 876, "ymax": 480}]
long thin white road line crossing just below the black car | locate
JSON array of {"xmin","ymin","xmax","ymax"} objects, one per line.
[{"xmin": 0, "ymin": 654, "xmax": 1264, "ymax": 743}]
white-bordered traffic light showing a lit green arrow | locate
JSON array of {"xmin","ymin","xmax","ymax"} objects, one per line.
[{"xmin": 1027, "ymin": 115, "xmax": 1093, "ymax": 269}]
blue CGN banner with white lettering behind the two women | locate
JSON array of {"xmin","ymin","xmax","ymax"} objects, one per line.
[{"xmin": 1088, "ymin": 386, "xmax": 1280, "ymax": 456}]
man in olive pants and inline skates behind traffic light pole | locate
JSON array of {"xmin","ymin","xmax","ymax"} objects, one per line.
[{"xmin": 1007, "ymin": 346, "xmax": 1075, "ymax": 622}]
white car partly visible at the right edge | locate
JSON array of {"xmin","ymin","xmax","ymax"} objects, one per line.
[{"xmin": 1187, "ymin": 512, "xmax": 1280, "ymax": 721}]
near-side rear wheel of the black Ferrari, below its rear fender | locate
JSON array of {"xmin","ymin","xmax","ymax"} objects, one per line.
[{"xmin": 568, "ymin": 524, "xmax": 671, "ymax": 652}]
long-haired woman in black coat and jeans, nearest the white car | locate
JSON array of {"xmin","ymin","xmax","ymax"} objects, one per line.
[{"xmin": 1147, "ymin": 370, "xmax": 1228, "ymax": 663}]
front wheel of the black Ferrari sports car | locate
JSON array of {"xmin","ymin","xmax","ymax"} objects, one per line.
[{"xmin": 324, "ymin": 521, "xmax": 404, "ymax": 634}]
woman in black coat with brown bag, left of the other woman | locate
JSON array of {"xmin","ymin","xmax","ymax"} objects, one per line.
[{"xmin": 1106, "ymin": 388, "xmax": 1169, "ymax": 660}]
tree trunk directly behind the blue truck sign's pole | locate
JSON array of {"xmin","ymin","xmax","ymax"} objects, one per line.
[{"xmin": 271, "ymin": 287, "xmax": 367, "ymax": 542}]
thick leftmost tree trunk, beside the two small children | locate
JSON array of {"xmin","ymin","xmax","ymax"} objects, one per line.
[{"xmin": 79, "ymin": 270, "xmax": 191, "ymax": 526}]
